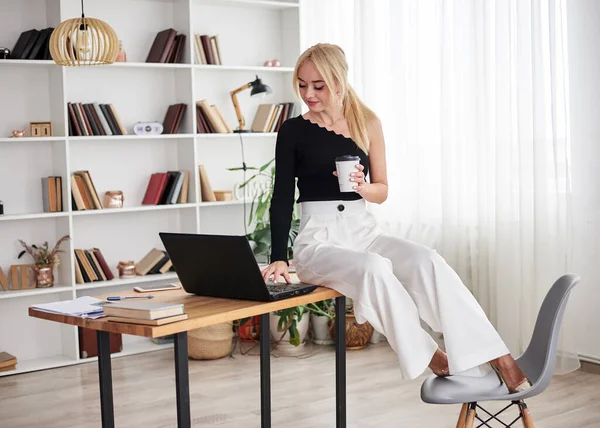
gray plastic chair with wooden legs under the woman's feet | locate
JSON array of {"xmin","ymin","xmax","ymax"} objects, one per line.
[{"xmin": 421, "ymin": 274, "xmax": 580, "ymax": 428}]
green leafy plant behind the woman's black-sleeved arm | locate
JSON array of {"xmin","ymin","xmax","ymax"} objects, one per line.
[{"xmin": 228, "ymin": 158, "xmax": 300, "ymax": 259}]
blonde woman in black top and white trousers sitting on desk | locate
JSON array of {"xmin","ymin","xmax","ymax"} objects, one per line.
[{"xmin": 262, "ymin": 44, "xmax": 530, "ymax": 392}]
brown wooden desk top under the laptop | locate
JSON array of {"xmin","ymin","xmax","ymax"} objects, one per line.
[{"xmin": 29, "ymin": 287, "xmax": 341, "ymax": 337}]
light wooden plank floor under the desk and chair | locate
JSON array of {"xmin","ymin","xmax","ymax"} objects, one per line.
[{"xmin": 0, "ymin": 343, "xmax": 600, "ymax": 428}]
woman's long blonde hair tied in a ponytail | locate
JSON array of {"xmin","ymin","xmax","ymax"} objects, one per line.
[{"xmin": 293, "ymin": 43, "xmax": 377, "ymax": 153}]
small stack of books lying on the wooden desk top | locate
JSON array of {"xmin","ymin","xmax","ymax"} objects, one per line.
[{"xmin": 104, "ymin": 299, "xmax": 188, "ymax": 325}]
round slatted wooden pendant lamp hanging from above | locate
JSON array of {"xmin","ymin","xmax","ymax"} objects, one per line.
[{"xmin": 49, "ymin": 0, "xmax": 120, "ymax": 66}]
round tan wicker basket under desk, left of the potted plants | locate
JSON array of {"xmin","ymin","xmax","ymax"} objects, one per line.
[{"xmin": 188, "ymin": 322, "xmax": 233, "ymax": 360}]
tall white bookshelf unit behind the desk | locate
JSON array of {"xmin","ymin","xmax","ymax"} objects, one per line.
[{"xmin": 0, "ymin": 0, "xmax": 301, "ymax": 376}]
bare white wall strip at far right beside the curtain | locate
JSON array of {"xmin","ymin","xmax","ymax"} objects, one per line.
[{"xmin": 567, "ymin": 0, "xmax": 600, "ymax": 361}]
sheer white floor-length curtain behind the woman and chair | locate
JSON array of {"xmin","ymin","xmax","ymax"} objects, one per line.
[{"xmin": 301, "ymin": 0, "xmax": 579, "ymax": 373}]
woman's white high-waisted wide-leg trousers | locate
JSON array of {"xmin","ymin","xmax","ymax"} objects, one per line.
[{"xmin": 294, "ymin": 199, "xmax": 509, "ymax": 379}]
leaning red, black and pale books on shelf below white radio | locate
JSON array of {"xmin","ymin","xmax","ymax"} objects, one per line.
[{"xmin": 142, "ymin": 170, "xmax": 190, "ymax": 205}]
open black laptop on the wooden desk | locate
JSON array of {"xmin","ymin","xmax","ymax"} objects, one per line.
[{"xmin": 159, "ymin": 232, "xmax": 317, "ymax": 302}]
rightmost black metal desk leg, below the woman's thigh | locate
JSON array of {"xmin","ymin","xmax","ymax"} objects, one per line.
[{"xmin": 335, "ymin": 296, "xmax": 346, "ymax": 428}]
